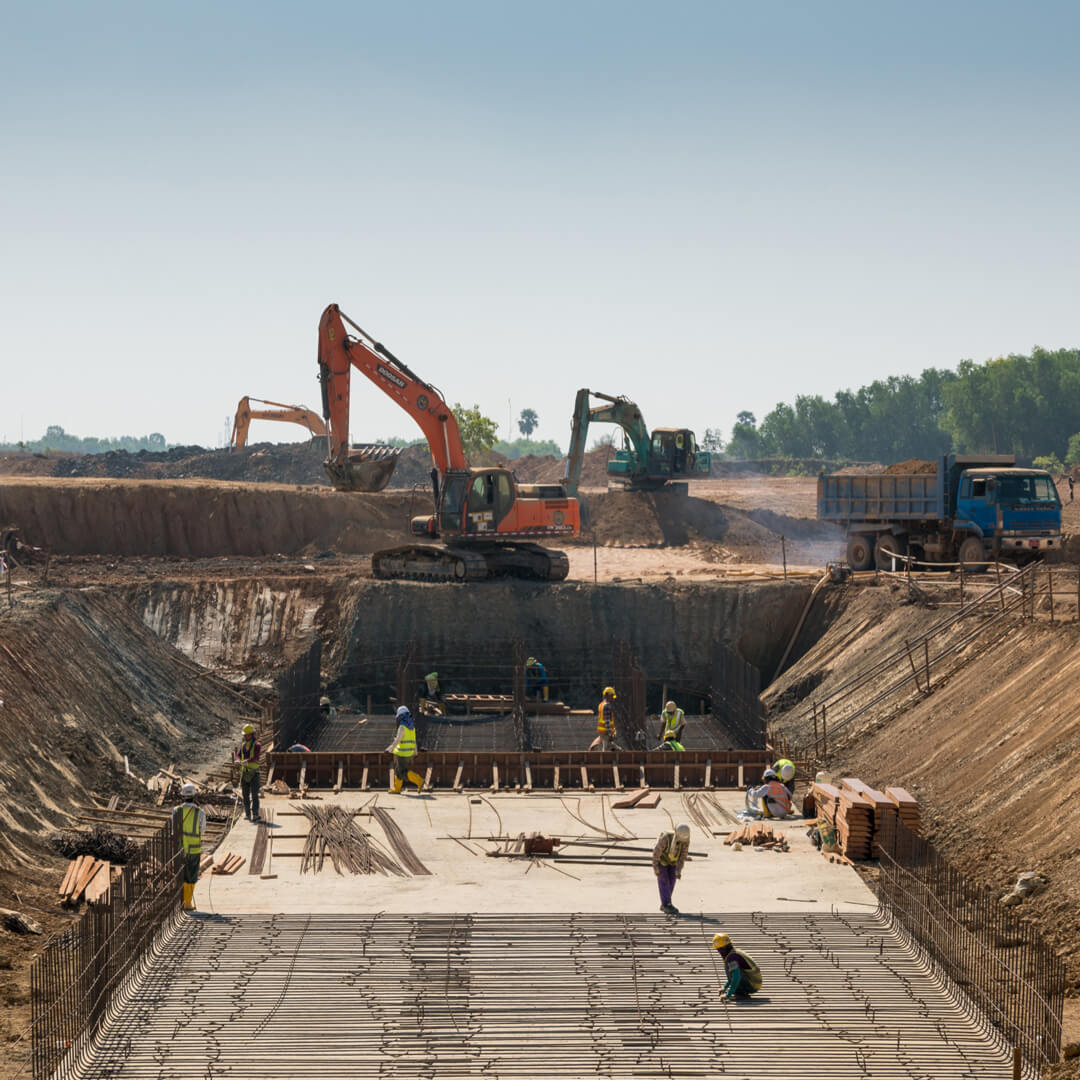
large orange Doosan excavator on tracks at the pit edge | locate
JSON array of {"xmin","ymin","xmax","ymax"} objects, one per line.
[{"xmin": 319, "ymin": 303, "xmax": 580, "ymax": 582}]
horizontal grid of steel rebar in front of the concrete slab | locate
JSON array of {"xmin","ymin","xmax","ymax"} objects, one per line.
[{"xmin": 69, "ymin": 914, "xmax": 1028, "ymax": 1080}]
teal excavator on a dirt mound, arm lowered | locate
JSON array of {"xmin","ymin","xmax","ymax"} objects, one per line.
[{"xmin": 563, "ymin": 389, "xmax": 713, "ymax": 498}]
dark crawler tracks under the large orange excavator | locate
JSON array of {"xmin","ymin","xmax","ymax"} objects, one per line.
[{"xmin": 372, "ymin": 543, "xmax": 570, "ymax": 584}]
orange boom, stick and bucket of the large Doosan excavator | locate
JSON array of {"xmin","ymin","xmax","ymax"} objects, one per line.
[{"xmin": 319, "ymin": 303, "xmax": 469, "ymax": 491}]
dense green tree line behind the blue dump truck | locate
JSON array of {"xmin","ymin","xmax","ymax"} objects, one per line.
[{"xmin": 703, "ymin": 348, "xmax": 1080, "ymax": 464}]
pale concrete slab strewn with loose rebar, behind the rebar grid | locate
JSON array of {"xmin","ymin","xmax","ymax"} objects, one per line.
[{"xmin": 195, "ymin": 791, "xmax": 877, "ymax": 915}]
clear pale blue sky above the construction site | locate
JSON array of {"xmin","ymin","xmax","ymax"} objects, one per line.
[{"xmin": 0, "ymin": 0, "xmax": 1080, "ymax": 446}]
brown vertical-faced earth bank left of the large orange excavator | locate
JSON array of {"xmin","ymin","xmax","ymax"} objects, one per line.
[{"xmin": 0, "ymin": 478, "xmax": 421, "ymax": 557}]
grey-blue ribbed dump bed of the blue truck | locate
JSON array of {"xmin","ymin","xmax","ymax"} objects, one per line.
[{"xmin": 818, "ymin": 468, "xmax": 945, "ymax": 522}]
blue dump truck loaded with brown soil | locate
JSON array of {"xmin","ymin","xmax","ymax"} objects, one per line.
[{"xmin": 818, "ymin": 454, "xmax": 1062, "ymax": 570}]
